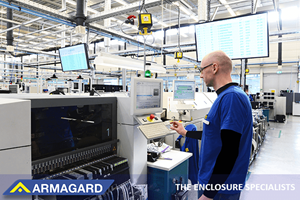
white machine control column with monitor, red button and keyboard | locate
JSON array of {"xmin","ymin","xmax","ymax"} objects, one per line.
[{"xmin": 117, "ymin": 78, "xmax": 176, "ymax": 184}]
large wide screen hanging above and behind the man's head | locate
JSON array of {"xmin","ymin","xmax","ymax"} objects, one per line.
[{"xmin": 195, "ymin": 13, "xmax": 269, "ymax": 62}]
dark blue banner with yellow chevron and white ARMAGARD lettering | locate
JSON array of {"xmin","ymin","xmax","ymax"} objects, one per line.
[{"xmin": 3, "ymin": 180, "xmax": 114, "ymax": 195}]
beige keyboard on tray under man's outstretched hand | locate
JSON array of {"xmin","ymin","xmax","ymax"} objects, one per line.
[{"xmin": 138, "ymin": 122, "xmax": 174, "ymax": 140}]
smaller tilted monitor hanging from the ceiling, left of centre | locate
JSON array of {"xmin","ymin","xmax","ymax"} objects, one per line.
[{"xmin": 59, "ymin": 44, "xmax": 90, "ymax": 72}]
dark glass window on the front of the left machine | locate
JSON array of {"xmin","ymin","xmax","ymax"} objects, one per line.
[{"xmin": 31, "ymin": 104, "xmax": 112, "ymax": 160}]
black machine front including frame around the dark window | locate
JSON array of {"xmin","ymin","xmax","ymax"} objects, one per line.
[{"xmin": 30, "ymin": 96, "xmax": 117, "ymax": 164}]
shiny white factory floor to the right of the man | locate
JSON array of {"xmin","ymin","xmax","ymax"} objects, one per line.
[{"xmin": 189, "ymin": 116, "xmax": 300, "ymax": 200}]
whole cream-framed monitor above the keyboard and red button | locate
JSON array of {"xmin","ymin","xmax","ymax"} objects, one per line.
[{"xmin": 130, "ymin": 77, "xmax": 163, "ymax": 115}]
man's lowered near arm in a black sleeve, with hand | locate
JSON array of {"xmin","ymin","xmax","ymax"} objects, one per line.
[{"xmin": 200, "ymin": 129, "xmax": 241, "ymax": 199}]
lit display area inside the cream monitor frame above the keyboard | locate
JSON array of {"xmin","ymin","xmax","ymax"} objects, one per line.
[{"xmin": 136, "ymin": 81, "xmax": 162, "ymax": 109}]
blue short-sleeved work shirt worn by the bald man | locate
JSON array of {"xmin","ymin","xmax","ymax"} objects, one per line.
[{"xmin": 198, "ymin": 85, "xmax": 253, "ymax": 194}]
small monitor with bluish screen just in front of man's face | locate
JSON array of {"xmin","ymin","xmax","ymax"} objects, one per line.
[{"xmin": 173, "ymin": 80, "xmax": 196, "ymax": 101}]
